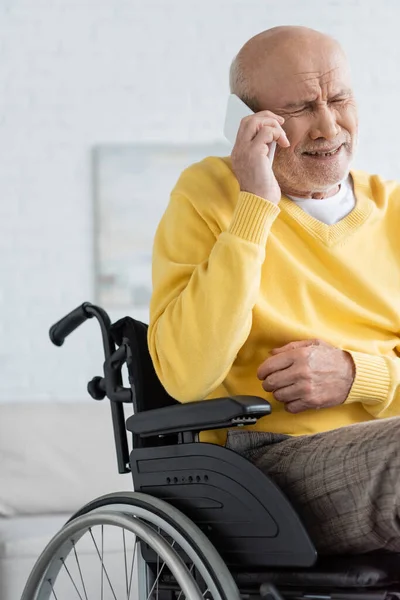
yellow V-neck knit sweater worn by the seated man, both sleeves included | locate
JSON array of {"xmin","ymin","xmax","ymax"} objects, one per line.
[{"xmin": 148, "ymin": 157, "xmax": 400, "ymax": 444}]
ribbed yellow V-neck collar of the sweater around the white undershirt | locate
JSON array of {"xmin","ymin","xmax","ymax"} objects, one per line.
[{"xmin": 279, "ymin": 171, "xmax": 374, "ymax": 246}]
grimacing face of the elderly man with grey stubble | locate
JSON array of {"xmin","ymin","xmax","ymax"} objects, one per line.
[{"xmin": 256, "ymin": 48, "xmax": 358, "ymax": 196}]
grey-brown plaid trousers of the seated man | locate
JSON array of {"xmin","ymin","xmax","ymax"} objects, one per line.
[{"xmin": 226, "ymin": 417, "xmax": 400, "ymax": 554}]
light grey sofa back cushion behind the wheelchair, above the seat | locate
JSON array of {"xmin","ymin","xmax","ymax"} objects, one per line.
[{"xmin": 0, "ymin": 400, "xmax": 133, "ymax": 516}]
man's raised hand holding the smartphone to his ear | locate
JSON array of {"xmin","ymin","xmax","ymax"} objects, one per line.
[{"xmin": 231, "ymin": 110, "xmax": 290, "ymax": 204}]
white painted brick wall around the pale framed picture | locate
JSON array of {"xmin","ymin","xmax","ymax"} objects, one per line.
[{"xmin": 0, "ymin": 0, "xmax": 400, "ymax": 401}]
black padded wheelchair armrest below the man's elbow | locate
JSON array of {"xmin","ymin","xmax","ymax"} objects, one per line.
[{"xmin": 126, "ymin": 396, "xmax": 271, "ymax": 437}]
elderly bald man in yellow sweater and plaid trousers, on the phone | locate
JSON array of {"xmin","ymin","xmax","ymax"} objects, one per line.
[{"xmin": 149, "ymin": 27, "xmax": 400, "ymax": 553}]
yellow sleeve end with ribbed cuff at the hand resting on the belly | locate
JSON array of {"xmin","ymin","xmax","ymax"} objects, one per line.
[{"xmin": 346, "ymin": 350, "xmax": 400, "ymax": 419}]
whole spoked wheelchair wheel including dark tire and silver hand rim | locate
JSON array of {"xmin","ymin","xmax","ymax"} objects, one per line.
[{"xmin": 21, "ymin": 492, "xmax": 240, "ymax": 600}]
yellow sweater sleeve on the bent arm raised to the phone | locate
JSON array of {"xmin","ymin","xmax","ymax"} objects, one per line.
[{"xmin": 148, "ymin": 192, "xmax": 280, "ymax": 402}]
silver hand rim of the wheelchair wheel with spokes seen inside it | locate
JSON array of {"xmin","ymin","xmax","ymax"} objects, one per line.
[{"xmin": 21, "ymin": 511, "xmax": 204, "ymax": 600}]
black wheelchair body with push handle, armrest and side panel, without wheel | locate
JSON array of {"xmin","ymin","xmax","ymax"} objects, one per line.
[{"xmin": 50, "ymin": 302, "xmax": 400, "ymax": 600}]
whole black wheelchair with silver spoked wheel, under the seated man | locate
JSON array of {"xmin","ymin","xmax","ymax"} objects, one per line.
[{"xmin": 22, "ymin": 302, "xmax": 400, "ymax": 600}]
